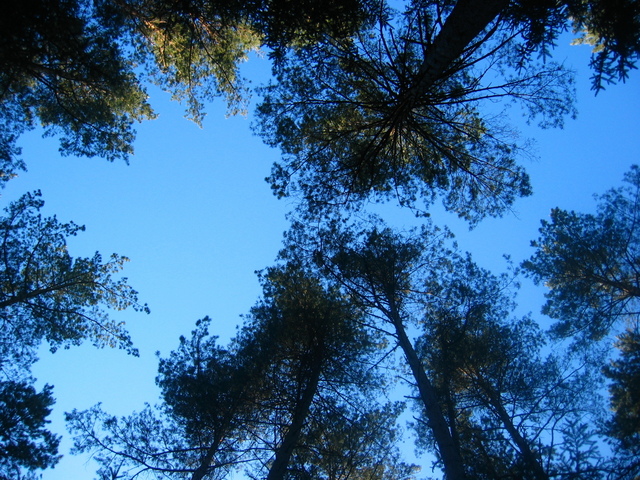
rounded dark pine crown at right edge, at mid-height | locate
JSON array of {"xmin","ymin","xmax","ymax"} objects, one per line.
[{"xmin": 523, "ymin": 166, "xmax": 640, "ymax": 339}]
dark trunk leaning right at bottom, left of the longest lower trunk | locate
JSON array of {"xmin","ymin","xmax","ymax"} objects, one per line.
[{"xmin": 267, "ymin": 355, "xmax": 322, "ymax": 480}]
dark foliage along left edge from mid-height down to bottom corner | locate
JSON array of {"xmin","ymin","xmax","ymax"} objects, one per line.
[{"xmin": 0, "ymin": 192, "xmax": 148, "ymax": 479}]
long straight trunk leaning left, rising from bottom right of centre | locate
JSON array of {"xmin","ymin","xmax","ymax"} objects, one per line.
[{"xmin": 388, "ymin": 302, "xmax": 466, "ymax": 480}]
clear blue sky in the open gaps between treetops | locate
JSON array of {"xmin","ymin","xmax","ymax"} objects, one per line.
[{"xmin": 0, "ymin": 34, "xmax": 640, "ymax": 480}]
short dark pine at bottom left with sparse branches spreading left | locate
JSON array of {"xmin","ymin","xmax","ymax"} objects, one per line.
[{"xmin": 67, "ymin": 318, "xmax": 262, "ymax": 479}]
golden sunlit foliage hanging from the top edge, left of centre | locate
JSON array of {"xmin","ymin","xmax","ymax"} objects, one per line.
[{"xmin": 98, "ymin": 0, "xmax": 260, "ymax": 124}]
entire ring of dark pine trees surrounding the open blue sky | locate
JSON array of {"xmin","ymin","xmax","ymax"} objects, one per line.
[{"xmin": 0, "ymin": 0, "xmax": 640, "ymax": 480}]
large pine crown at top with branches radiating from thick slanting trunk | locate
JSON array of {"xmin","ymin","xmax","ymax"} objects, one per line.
[{"xmin": 258, "ymin": 0, "xmax": 640, "ymax": 224}]
